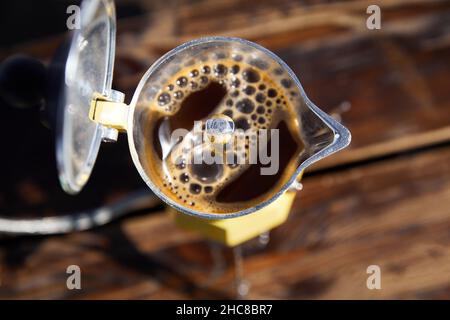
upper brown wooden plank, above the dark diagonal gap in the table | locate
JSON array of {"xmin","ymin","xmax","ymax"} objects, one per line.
[{"xmin": 1, "ymin": 0, "xmax": 450, "ymax": 168}]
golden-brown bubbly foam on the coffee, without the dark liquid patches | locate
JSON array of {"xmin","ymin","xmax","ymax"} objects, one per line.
[{"xmin": 142, "ymin": 48, "xmax": 302, "ymax": 213}]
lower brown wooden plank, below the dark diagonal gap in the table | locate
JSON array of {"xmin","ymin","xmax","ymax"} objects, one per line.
[{"xmin": 0, "ymin": 147, "xmax": 450, "ymax": 299}]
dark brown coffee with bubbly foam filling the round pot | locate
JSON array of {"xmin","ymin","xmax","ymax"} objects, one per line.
[{"xmin": 145, "ymin": 53, "xmax": 304, "ymax": 213}]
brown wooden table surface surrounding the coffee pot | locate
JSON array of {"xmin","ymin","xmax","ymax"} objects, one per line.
[{"xmin": 0, "ymin": 0, "xmax": 450, "ymax": 299}]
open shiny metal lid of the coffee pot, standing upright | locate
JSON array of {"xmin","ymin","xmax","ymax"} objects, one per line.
[{"xmin": 56, "ymin": 0, "xmax": 116, "ymax": 194}]
